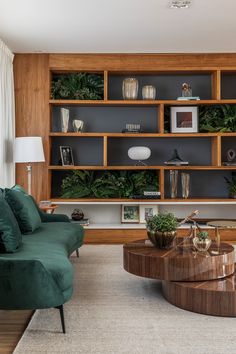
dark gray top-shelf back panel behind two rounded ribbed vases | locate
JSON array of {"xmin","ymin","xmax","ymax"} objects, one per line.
[{"xmin": 108, "ymin": 74, "xmax": 211, "ymax": 100}]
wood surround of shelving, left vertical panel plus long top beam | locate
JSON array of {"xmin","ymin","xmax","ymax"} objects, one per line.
[{"xmin": 14, "ymin": 54, "xmax": 236, "ymax": 200}]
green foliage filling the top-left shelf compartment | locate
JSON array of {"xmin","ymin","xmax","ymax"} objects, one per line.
[{"xmin": 51, "ymin": 73, "xmax": 104, "ymax": 100}]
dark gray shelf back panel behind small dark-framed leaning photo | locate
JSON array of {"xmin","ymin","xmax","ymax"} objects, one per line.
[{"xmin": 51, "ymin": 137, "xmax": 103, "ymax": 166}]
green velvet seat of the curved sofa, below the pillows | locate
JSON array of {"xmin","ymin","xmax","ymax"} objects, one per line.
[{"xmin": 0, "ymin": 222, "xmax": 83, "ymax": 292}]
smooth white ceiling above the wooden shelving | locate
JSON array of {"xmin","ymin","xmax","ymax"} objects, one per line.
[{"xmin": 0, "ymin": 0, "xmax": 236, "ymax": 53}]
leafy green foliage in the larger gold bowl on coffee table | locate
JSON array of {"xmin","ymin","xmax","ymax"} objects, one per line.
[{"xmin": 147, "ymin": 213, "xmax": 178, "ymax": 232}]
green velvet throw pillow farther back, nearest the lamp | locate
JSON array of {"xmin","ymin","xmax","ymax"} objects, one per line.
[{"xmin": 5, "ymin": 186, "xmax": 41, "ymax": 234}]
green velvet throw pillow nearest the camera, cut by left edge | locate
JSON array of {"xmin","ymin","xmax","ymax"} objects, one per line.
[{"xmin": 0, "ymin": 191, "xmax": 22, "ymax": 253}]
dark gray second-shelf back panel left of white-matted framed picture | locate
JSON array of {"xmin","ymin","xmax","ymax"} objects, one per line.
[{"xmin": 52, "ymin": 106, "xmax": 158, "ymax": 133}]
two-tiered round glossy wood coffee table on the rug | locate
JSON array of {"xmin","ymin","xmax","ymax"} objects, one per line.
[{"xmin": 124, "ymin": 238, "xmax": 236, "ymax": 316}]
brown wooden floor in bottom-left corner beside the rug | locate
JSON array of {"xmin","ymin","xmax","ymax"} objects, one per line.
[{"xmin": 0, "ymin": 310, "xmax": 33, "ymax": 354}]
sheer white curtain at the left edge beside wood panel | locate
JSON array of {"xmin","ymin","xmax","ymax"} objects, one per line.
[{"xmin": 0, "ymin": 39, "xmax": 15, "ymax": 188}]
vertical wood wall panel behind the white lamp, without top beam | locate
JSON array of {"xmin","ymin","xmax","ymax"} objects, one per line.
[{"xmin": 14, "ymin": 54, "xmax": 49, "ymax": 200}]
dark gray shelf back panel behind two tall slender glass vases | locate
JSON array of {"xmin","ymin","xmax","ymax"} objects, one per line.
[{"xmin": 165, "ymin": 170, "xmax": 231, "ymax": 199}]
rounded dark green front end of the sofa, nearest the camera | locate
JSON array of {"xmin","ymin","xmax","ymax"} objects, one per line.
[{"xmin": 0, "ymin": 257, "xmax": 69, "ymax": 310}]
